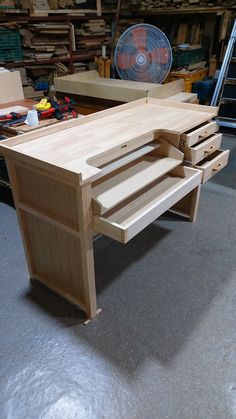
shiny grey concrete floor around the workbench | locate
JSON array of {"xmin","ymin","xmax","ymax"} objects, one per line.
[{"xmin": 0, "ymin": 137, "xmax": 236, "ymax": 419}]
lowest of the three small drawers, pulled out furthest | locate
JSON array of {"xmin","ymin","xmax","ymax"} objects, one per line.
[{"xmin": 194, "ymin": 150, "xmax": 229, "ymax": 183}]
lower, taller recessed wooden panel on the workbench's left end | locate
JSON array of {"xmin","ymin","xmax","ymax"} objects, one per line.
[{"xmin": 21, "ymin": 210, "xmax": 85, "ymax": 308}]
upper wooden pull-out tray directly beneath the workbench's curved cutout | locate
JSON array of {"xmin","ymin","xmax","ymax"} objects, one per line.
[{"xmin": 92, "ymin": 138, "xmax": 183, "ymax": 215}]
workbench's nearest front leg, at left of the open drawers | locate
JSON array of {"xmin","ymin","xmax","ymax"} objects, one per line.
[{"xmin": 77, "ymin": 185, "xmax": 97, "ymax": 319}]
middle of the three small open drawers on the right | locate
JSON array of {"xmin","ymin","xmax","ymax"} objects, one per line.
[{"xmin": 181, "ymin": 134, "xmax": 222, "ymax": 164}]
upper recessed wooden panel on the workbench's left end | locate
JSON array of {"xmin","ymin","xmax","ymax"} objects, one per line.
[{"xmin": 15, "ymin": 163, "xmax": 79, "ymax": 231}]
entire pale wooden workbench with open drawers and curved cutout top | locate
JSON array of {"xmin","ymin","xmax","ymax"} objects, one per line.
[{"xmin": 0, "ymin": 98, "xmax": 228, "ymax": 319}]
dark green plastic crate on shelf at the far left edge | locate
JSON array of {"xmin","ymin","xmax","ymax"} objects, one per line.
[{"xmin": 0, "ymin": 29, "xmax": 23, "ymax": 61}]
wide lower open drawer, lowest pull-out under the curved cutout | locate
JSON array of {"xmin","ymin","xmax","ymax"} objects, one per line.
[{"xmin": 94, "ymin": 165, "xmax": 202, "ymax": 243}]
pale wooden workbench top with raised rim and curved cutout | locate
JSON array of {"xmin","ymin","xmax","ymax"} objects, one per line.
[{"xmin": 0, "ymin": 98, "xmax": 217, "ymax": 184}]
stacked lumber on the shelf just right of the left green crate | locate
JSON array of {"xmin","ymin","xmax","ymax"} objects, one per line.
[{"xmin": 21, "ymin": 22, "xmax": 69, "ymax": 61}]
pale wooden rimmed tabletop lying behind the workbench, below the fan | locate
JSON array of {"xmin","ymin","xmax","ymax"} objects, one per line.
[{"xmin": 54, "ymin": 70, "xmax": 184, "ymax": 102}]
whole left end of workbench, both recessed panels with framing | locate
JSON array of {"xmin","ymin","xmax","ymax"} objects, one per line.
[{"xmin": 7, "ymin": 160, "xmax": 93, "ymax": 317}]
